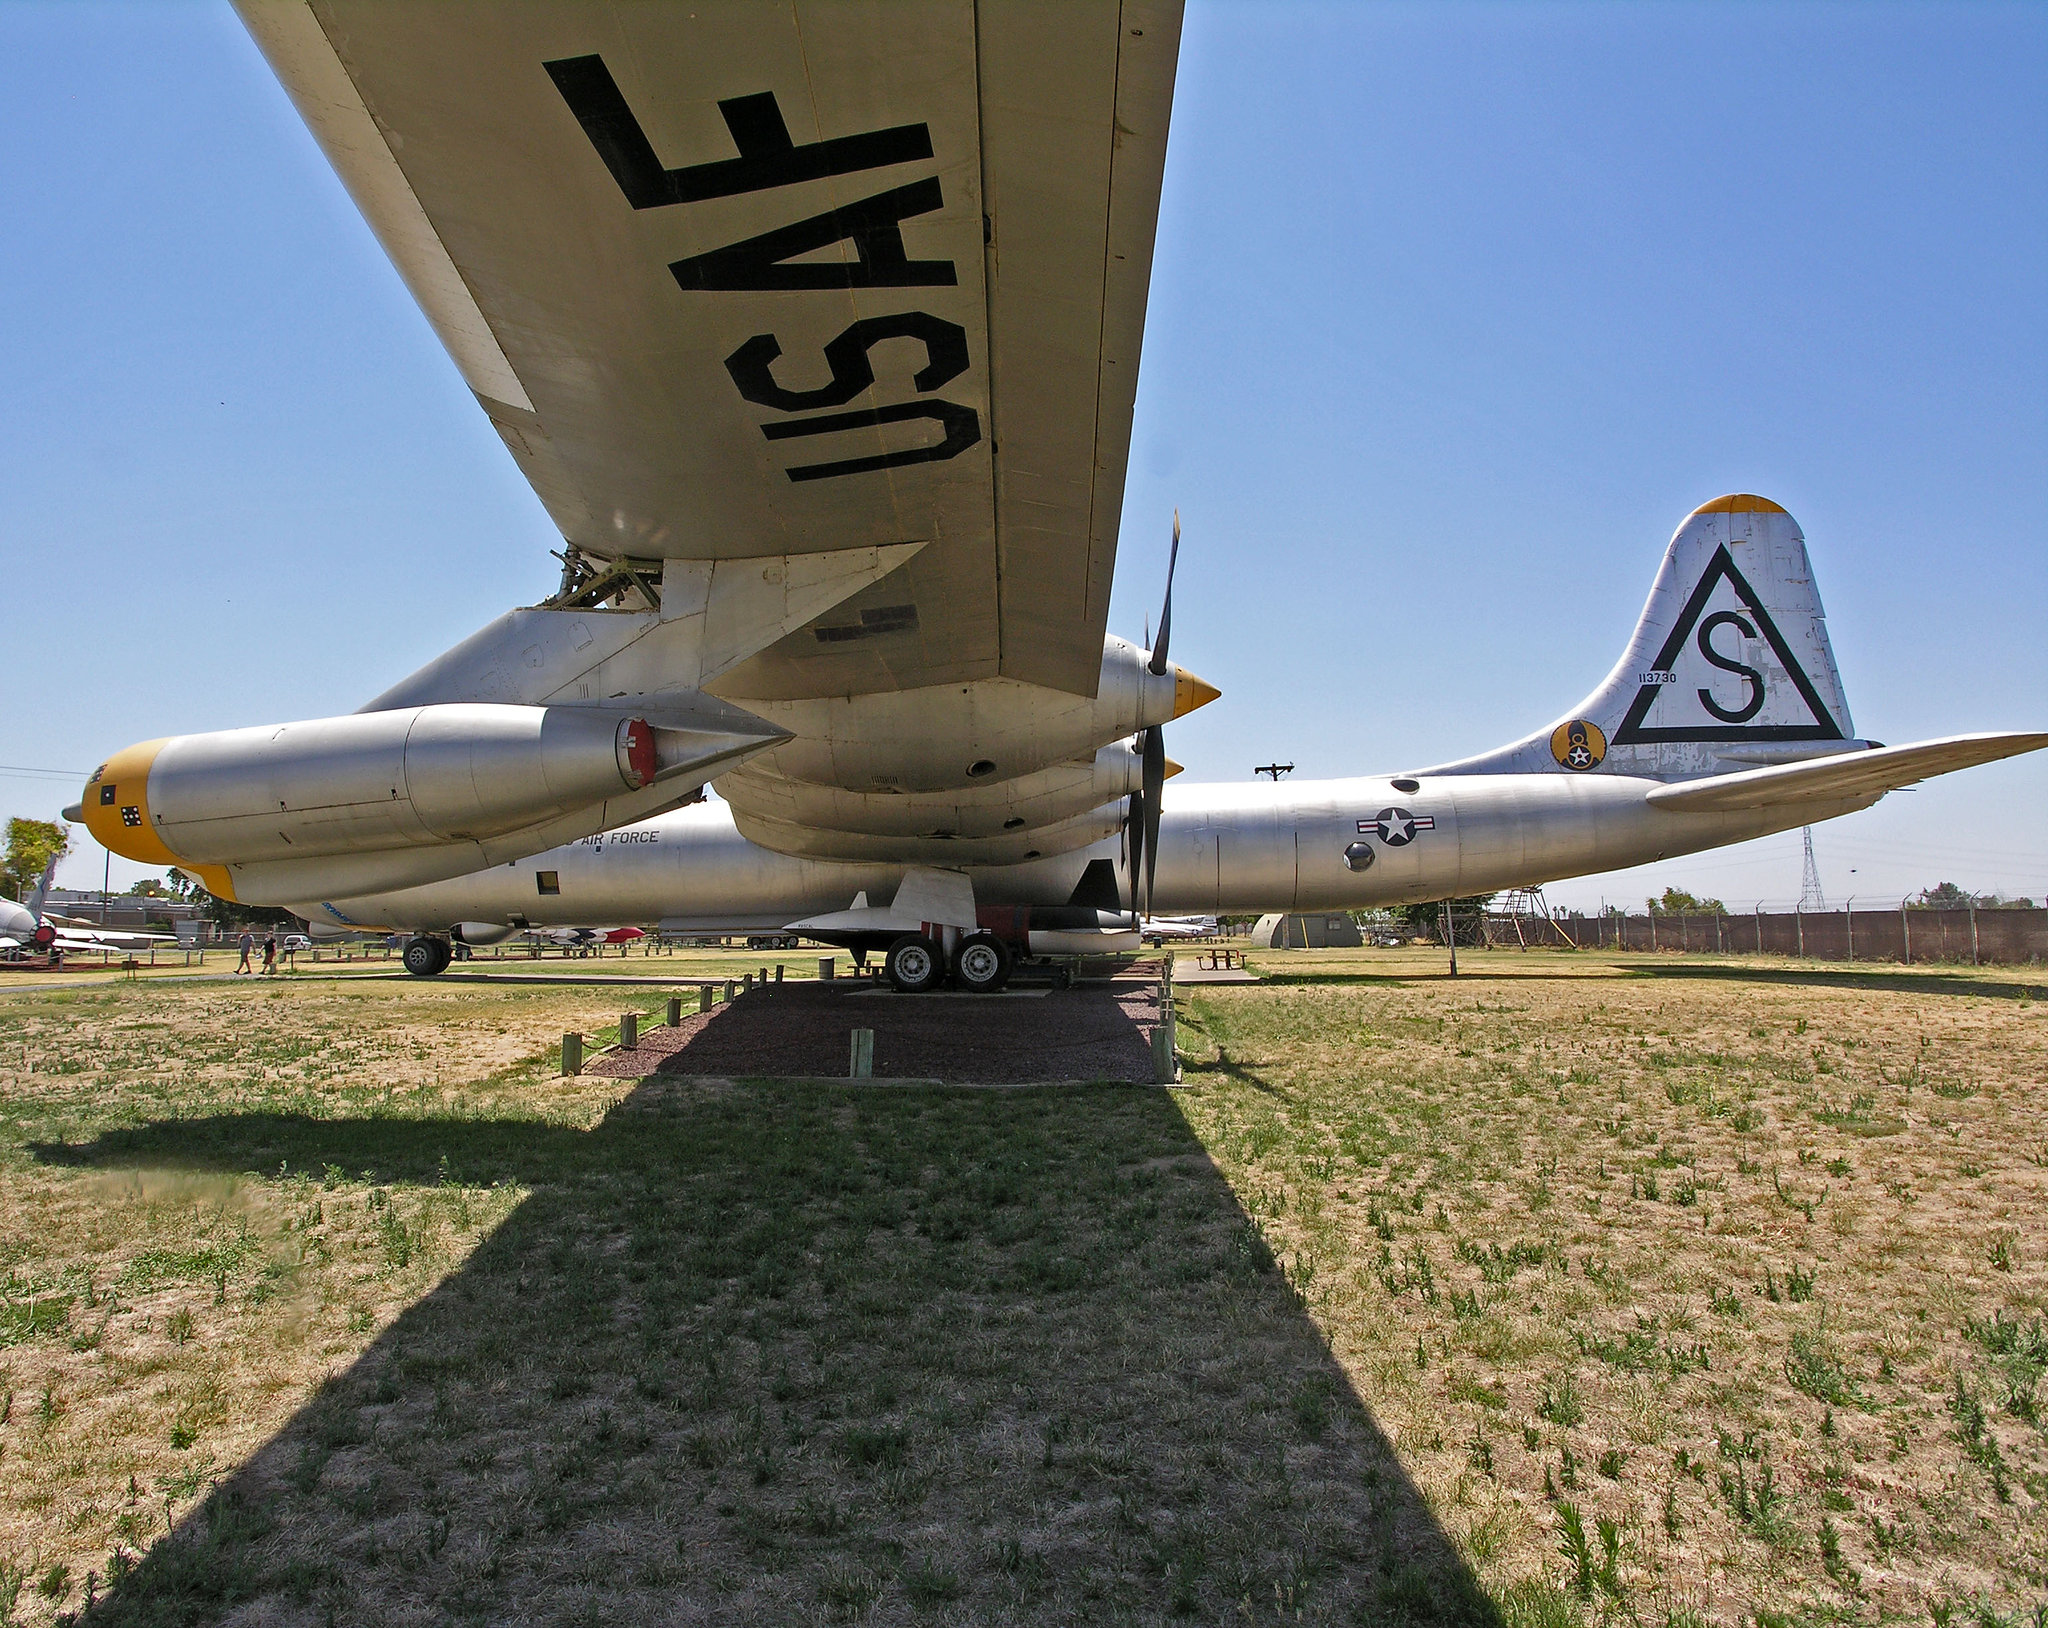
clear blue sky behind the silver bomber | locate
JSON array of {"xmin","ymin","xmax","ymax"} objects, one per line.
[{"xmin": 0, "ymin": 0, "xmax": 2048, "ymax": 905}]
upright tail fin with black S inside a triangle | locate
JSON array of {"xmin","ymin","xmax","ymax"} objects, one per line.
[{"xmin": 1434, "ymin": 494, "xmax": 1866, "ymax": 780}]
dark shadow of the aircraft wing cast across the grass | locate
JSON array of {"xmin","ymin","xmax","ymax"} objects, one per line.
[{"xmin": 35, "ymin": 1077, "xmax": 1497, "ymax": 1624}]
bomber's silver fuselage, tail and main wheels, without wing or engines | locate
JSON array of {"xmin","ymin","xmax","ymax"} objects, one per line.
[{"xmin": 280, "ymin": 496, "xmax": 2048, "ymax": 987}]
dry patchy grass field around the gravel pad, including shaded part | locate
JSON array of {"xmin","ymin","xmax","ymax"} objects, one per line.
[{"xmin": 0, "ymin": 950, "xmax": 2048, "ymax": 1628}]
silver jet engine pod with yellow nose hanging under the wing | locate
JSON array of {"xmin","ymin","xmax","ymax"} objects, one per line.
[{"xmin": 82, "ymin": 702, "xmax": 733, "ymax": 866}]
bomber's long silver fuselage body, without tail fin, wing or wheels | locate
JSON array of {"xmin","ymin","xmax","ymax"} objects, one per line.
[{"xmin": 295, "ymin": 774, "xmax": 1876, "ymax": 932}]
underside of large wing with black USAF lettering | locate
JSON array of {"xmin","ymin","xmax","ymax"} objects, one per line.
[{"xmin": 238, "ymin": 0, "xmax": 1180, "ymax": 696}]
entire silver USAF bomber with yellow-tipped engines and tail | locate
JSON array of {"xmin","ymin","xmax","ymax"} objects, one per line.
[{"xmin": 68, "ymin": 0, "xmax": 2048, "ymax": 989}]
